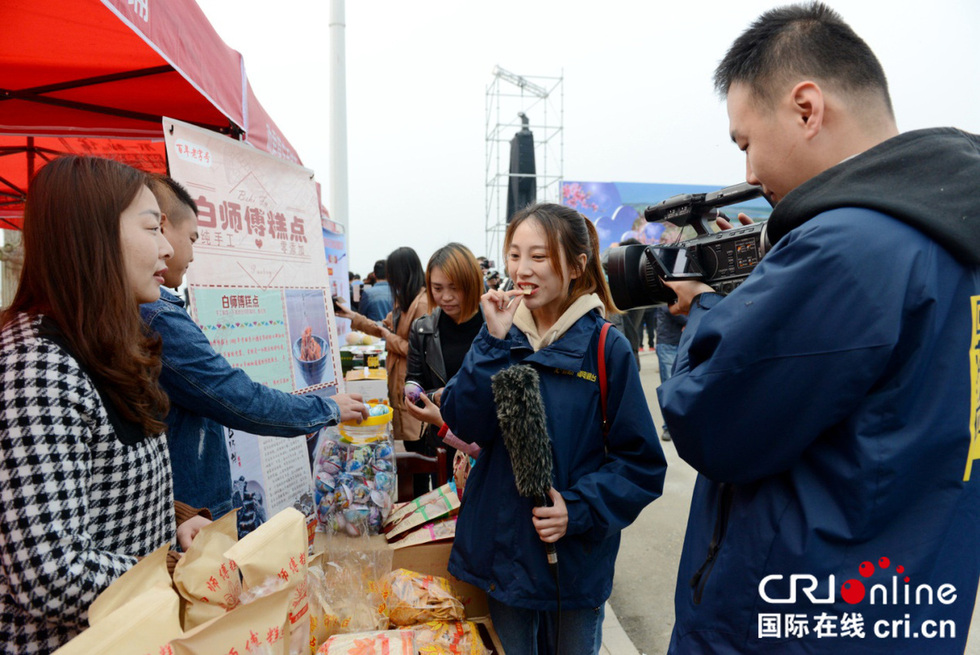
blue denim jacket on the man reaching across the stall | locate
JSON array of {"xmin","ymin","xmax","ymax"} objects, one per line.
[{"xmin": 140, "ymin": 289, "xmax": 340, "ymax": 518}]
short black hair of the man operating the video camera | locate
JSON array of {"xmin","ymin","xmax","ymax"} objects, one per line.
[{"xmin": 714, "ymin": 2, "xmax": 894, "ymax": 115}]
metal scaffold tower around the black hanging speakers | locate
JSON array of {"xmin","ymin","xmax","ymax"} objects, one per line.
[{"xmin": 485, "ymin": 66, "xmax": 565, "ymax": 267}]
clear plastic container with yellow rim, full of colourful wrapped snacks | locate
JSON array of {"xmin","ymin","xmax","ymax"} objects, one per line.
[{"xmin": 313, "ymin": 405, "xmax": 397, "ymax": 537}]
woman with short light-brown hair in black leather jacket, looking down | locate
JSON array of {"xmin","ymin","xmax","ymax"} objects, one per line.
[{"xmin": 405, "ymin": 243, "xmax": 483, "ymax": 495}]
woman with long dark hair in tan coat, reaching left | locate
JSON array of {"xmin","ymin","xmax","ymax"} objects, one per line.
[{"xmin": 337, "ymin": 247, "xmax": 429, "ymax": 448}]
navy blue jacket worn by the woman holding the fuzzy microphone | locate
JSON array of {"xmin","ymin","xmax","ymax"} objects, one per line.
[{"xmin": 442, "ymin": 311, "xmax": 667, "ymax": 610}]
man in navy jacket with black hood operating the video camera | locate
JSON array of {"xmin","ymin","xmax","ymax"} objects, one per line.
[{"xmin": 659, "ymin": 3, "xmax": 980, "ymax": 655}]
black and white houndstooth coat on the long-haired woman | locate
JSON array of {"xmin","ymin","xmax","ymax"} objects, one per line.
[{"xmin": 0, "ymin": 315, "xmax": 175, "ymax": 653}]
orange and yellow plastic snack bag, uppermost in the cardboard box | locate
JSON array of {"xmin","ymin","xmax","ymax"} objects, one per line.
[{"xmin": 381, "ymin": 569, "xmax": 466, "ymax": 626}]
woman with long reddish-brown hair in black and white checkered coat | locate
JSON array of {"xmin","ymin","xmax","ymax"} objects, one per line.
[{"xmin": 0, "ymin": 156, "xmax": 192, "ymax": 653}]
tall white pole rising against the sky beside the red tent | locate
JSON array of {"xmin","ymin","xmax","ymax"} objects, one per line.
[{"xmin": 327, "ymin": 0, "xmax": 350, "ymax": 231}]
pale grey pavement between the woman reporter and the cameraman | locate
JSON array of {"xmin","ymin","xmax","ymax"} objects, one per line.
[{"xmin": 603, "ymin": 352, "xmax": 980, "ymax": 655}]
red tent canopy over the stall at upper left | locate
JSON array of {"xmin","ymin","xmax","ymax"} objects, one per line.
[{"xmin": 0, "ymin": 0, "xmax": 299, "ymax": 227}]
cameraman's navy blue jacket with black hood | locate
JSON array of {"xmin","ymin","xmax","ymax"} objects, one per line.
[{"xmin": 659, "ymin": 125, "xmax": 980, "ymax": 655}]
